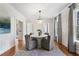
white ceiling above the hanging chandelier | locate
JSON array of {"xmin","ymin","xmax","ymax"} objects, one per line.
[{"xmin": 11, "ymin": 3, "xmax": 68, "ymax": 20}]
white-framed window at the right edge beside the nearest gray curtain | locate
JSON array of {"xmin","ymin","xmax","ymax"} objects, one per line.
[{"xmin": 73, "ymin": 9, "xmax": 79, "ymax": 41}]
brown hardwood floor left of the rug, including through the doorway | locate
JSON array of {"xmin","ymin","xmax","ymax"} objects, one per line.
[{"xmin": 0, "ymin": 40, "xmax": 24, "ymax": 56}]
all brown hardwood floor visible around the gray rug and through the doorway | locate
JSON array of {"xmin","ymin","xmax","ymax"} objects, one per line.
[{"xmin": 0, "ymin": 40, "xmax": 79, "ymax": 56}]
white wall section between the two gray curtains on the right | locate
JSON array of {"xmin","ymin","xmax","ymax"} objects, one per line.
[{"xmin": 61, "ymin": 8, "xmax": 69, "ymax": 47}]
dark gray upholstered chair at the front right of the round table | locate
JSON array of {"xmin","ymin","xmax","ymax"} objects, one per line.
[{"xmin": 41, "ymin": 35, "xmax": 50, "ymax": 50}]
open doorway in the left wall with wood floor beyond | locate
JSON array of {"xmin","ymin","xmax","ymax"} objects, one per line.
[{"xmin": 16, "ymin": 20, "xmax": 24, "ymax": 50}]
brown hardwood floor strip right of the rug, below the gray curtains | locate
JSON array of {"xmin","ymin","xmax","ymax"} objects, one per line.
[{"xmin": 55, "ymin": 41, "xmax": 79, "ymax": 56}]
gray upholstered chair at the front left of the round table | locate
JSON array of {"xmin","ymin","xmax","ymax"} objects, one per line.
[{"xmin": 25, "ymin": 34, "xmax": 37, "ymax": 50}]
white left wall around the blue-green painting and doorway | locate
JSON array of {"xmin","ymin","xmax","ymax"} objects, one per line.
[{"xmin": 0, "ymin": 4, "xmax": 26, "ymax": 54}]
